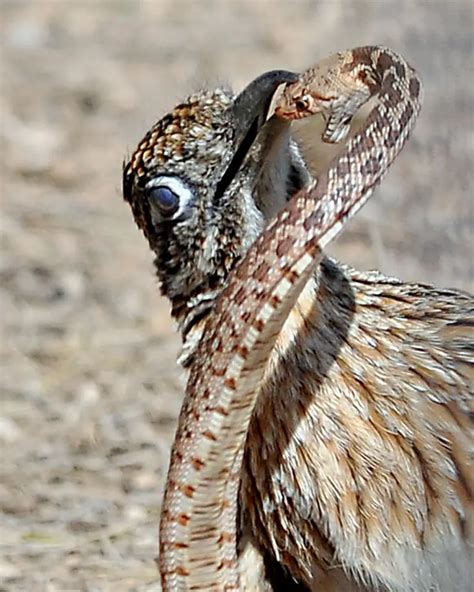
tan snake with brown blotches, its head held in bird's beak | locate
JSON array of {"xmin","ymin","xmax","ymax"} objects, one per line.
[{"xmin": 159, "ymin": 47, "xmax": 421, "ymax": 592}]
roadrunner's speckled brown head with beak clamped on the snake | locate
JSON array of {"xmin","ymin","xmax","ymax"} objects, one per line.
[{"xmin": 123, "ymin": 70, "xmax": 308, "ymax": 350}]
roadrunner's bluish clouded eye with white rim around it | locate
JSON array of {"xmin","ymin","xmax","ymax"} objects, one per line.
[{"xmin": 146, "ymin": 176, "xmax": 193, "ymax": 224}]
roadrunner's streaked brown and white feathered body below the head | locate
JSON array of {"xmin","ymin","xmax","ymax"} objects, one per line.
[{"xmin": 241, "ymin": 259, "xmax": 474, "ymax": 590}]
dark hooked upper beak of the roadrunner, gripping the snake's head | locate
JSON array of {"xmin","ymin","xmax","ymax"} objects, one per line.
[{"xmin": 214, "ymin": 70, "xmax": 298, "ymax": 200}]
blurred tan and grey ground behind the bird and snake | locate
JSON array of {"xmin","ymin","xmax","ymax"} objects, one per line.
[{"xmin": 0, "ymin": 0, "xmax": 474, "ymax": 592}]
